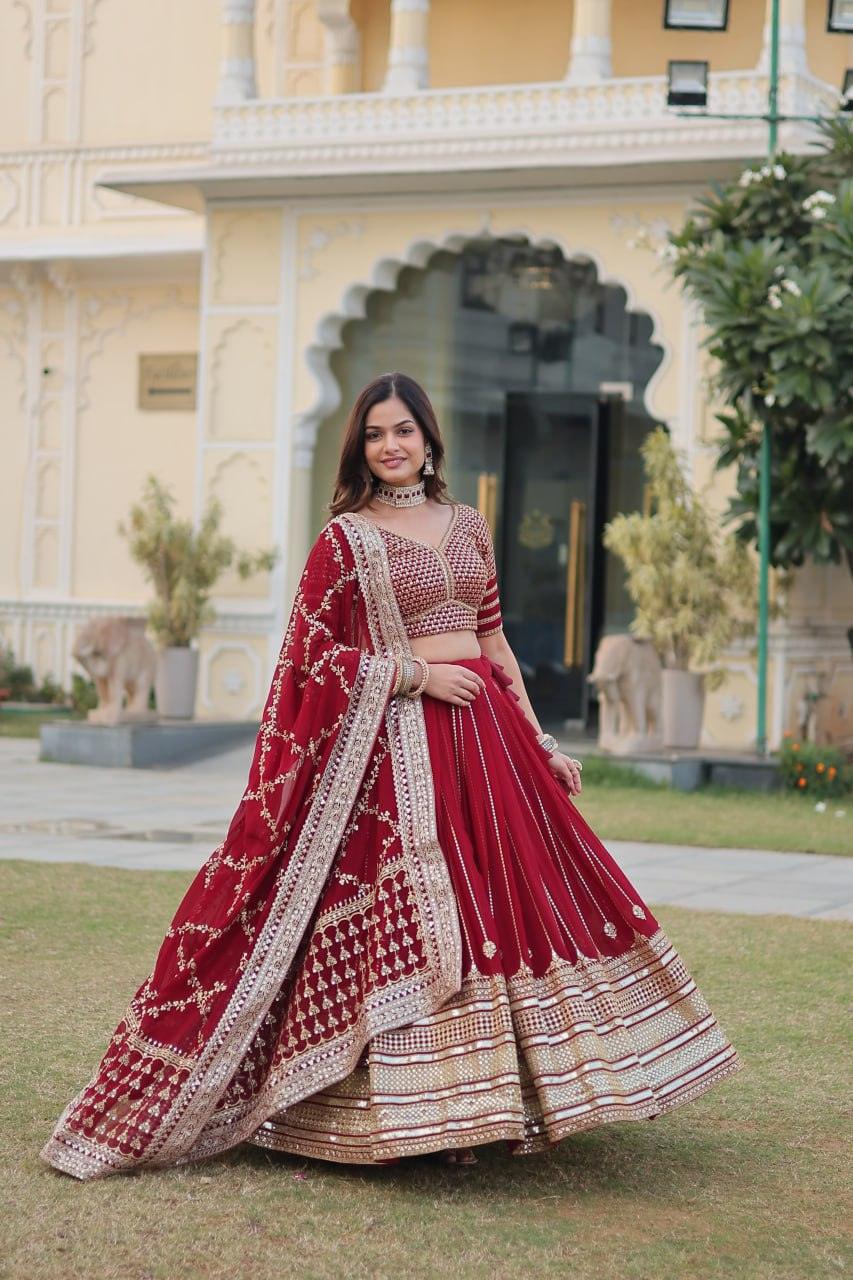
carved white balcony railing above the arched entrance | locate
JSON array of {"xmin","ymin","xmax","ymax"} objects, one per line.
[{"xmin": 213, "ymin": 72, "xmax": 838, "ymax": 172}]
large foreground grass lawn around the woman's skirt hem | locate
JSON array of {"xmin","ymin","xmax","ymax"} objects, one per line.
[{"xmin": 0, "ymin": 860, "xmax": 853, "ymax": 1280}]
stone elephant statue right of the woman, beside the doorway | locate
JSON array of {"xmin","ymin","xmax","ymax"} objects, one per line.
[{"xmin": 588, "ymin": 635, "xmax": 662, "ymax": 754}]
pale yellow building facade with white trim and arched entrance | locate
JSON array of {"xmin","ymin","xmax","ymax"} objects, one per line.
[{"xmin": 0, "ymin": 0, "xmax": 853, "ymax": 749}]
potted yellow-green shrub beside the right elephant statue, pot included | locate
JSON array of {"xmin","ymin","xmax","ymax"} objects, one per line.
[{"xmin": 605, "ymin": 428, "xmax": 756, "ymax": 748}]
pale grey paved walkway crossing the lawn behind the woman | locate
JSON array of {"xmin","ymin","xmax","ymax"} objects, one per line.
[{"xmin": 0, "ymin": 739, "xmax": 853, "ymax": 920}]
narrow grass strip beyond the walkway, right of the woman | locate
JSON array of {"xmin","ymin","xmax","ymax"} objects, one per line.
[{"xmin": 578, "ymin": 756, "xmax": 853, "ymax": 855}]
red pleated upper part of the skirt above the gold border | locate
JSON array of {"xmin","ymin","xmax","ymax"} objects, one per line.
[{"xmin": 424, "ymin": 657, "xmax": 658, "ymax": 975}]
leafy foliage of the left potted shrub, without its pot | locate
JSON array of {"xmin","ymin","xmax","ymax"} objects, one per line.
[{"xmin": 119, "ymin": 476, "xmax": 277, "ymax": 648}]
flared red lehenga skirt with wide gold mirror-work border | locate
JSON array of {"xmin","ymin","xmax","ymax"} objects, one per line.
[{"xmin": 251, "ymin": 657, "xmax": 740, "ymax": 1164}]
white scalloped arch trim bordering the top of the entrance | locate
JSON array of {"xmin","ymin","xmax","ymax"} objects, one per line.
[{"xmin": 293, "ymin": 225, "xmax": 672, "ymax": 470}]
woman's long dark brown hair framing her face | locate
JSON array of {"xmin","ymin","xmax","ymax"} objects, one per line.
[{"xmin": 329, "ymin": 374, "xmax": 450, "ymax": 516}]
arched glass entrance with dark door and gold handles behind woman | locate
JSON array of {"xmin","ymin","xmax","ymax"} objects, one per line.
[{"xmin": 314, "ymin": 239, "xmax": 662, "ymax": 726}]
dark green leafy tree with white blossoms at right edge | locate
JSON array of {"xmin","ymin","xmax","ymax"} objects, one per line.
[{"xmin": 663, "ymin": 116, "xmax": 853, "ymax": 573}]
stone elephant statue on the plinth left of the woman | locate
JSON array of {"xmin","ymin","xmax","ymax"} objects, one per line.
[{"xmin": 72, "ymin": 617, "xmax": 156, "ymax": 724}]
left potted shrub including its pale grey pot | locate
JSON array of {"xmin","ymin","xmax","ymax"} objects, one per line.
[{"xmin": 119, "ymin": 475, "xmax": 277, "ymax": 719}]
